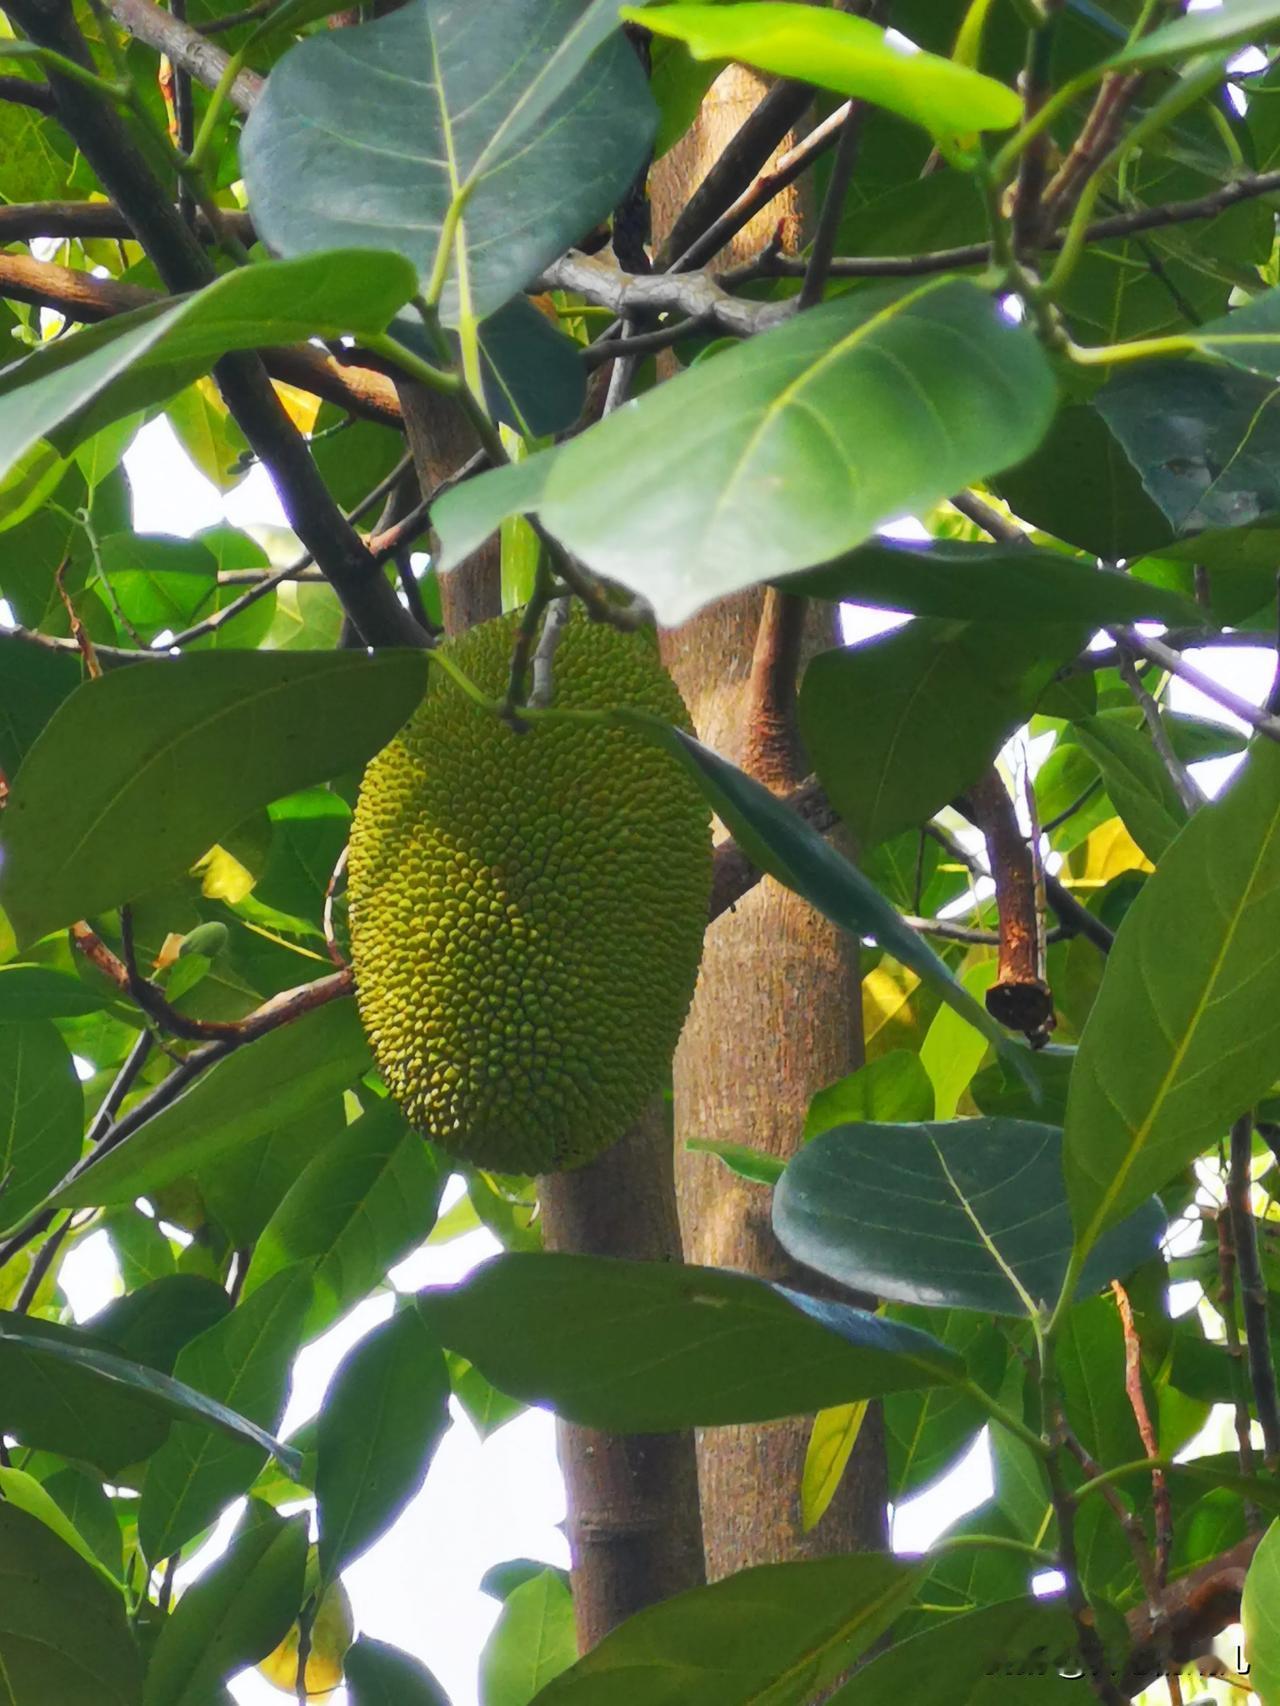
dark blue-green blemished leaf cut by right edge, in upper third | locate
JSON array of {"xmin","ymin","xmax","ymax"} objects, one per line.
[{"xmin": 1094, "ymin": 362, "xmax": 1280, "ymax": 532}]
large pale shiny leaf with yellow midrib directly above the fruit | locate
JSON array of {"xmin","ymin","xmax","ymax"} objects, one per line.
[{"xmin": 435, "ymin": 278, "xmax": 1055, "ymax": 624}]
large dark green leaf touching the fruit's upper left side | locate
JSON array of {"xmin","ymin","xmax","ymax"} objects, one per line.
[{"xmin": 0, "ymin": 652, "xmax": 427, "ymax": 942}]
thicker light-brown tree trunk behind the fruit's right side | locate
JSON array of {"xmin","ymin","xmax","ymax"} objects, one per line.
[{"xmin": 652, "ymin": 68, "xmax": 886, "ymax": 1578}]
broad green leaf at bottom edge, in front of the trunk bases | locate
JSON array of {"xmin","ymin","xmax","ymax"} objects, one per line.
[{"xmin": 525, "ymin": 1552, "xmax": 922, "ymax": 1706}]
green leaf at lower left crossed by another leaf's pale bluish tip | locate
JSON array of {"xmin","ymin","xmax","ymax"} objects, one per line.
[{"xmin": 138, "ymin": 1268, "xmax": 311, "ymax": 1564}]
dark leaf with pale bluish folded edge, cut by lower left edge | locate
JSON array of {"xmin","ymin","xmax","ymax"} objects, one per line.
[{"xmin": 0, "ymin": 1312, "xmax": 299, "ymax": 1472}]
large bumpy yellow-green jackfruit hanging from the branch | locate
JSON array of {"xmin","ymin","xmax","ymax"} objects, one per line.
[{"xmin": 348, "ymin": 614, "xmax": 712, "ymax": 1174}]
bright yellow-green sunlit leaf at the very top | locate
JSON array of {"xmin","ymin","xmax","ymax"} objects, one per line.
[{"xmin": 621, "ymin": 0, "xmax": 1022, "ymax": 138}]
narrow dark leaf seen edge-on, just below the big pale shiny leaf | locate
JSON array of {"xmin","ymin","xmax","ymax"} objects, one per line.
[{"xmin": 783, "ymin": 539, "xmax": 1203, "ymax": 627}]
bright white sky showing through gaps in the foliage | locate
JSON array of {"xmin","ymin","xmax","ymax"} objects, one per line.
[{"xmin": 37, "ymin": 418, "xmax": 1273, "ymax": 1706}]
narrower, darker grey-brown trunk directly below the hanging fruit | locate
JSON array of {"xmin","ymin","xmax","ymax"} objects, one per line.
[{"xmin": 539, "ymin": 1099, "xmax": 707, "ymax": 1653}]
